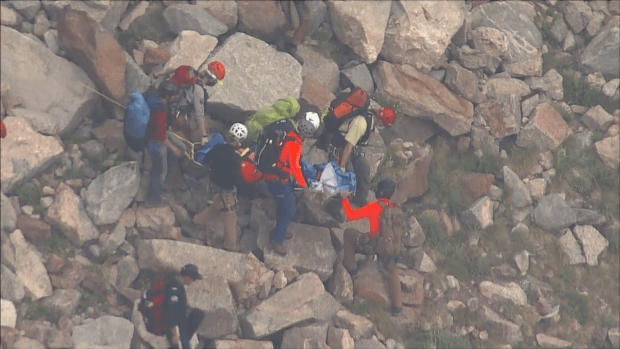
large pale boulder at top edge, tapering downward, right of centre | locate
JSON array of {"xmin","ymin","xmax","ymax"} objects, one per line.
[{"xmin": 381, "ymin": 1, "xmax": 464, "ymax": 72}]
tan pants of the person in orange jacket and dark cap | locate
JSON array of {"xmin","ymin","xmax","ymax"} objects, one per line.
[{"xmin": 342, "ymin": 228, "xmax": 403, "ymax": 308}]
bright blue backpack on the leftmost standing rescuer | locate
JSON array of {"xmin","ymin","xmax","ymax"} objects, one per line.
[{"xmin": 123, "ymin": 90, "xmax": 151, "ymax": 152}]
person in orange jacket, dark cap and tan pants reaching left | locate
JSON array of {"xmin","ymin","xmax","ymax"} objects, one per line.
[{"xmin": 342, "ymin": 178, "xmax": 404, "ymax": 315}]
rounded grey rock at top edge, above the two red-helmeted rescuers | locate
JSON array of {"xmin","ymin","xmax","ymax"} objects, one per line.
[{"xmin": 164, "ymin": 4, "xmax": 228, "ymax": 36}]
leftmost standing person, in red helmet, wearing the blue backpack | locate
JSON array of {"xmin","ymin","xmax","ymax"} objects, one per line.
[{"xmin": 144, "ymin": 80, "xmax": 185, "ymax": 207}]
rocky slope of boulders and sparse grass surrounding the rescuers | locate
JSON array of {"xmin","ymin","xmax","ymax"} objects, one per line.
[{"xmin": 0, "ymin": 0, "xmax": 620, "ymax": 348}]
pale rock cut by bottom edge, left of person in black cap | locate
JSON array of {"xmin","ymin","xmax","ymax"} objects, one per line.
[{"xmin": 72, "ymin": 315, "xmax": 134, "ymax": 349}]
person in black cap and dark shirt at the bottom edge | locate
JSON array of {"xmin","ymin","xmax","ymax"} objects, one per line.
[{"xmin": 164, "ymin": 264, "xmax": 204, "ymax": 349}]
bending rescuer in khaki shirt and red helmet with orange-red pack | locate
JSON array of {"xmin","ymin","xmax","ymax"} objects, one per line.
[{"xmin": 322, "ymin": 107, "xmax": 396, "ymax": 211}]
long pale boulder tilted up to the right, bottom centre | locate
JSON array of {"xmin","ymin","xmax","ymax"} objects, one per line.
[{"xmin": 240, "ymin": 273, "xmax": 325, "ymax": 338}]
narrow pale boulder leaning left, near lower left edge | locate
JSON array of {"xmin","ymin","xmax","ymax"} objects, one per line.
[{"xmin": 9, "ymin": 230, "xmax": 52, "ymax": 300}]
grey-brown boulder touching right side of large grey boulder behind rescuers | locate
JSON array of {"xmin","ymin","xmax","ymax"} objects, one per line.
[{"xmin": 297, "ymin": 44, "xmax": 340, "ymax": 94}]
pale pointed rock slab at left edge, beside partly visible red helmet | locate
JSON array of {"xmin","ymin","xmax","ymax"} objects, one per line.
[{"xmin": 0, "ymin": 117, "xmax": 63, "ymax": 193}]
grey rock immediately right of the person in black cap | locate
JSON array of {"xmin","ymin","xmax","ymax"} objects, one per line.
[{"xmin": 187, "ymin": 276, "xmax": 239, "ymax": 339}]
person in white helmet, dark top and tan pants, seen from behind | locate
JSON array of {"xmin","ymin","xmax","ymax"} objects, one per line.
[{"xmin": 203, "ymin": 123, "xmax": 248, "ymax": 251}]
